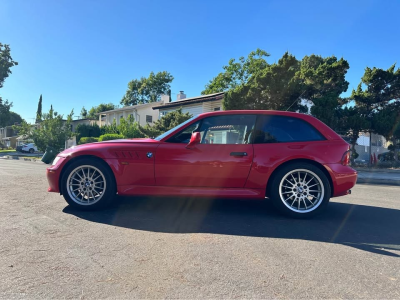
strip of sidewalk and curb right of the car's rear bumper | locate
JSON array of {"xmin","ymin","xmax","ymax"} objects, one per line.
[{"xmin": 357, "ymin": 169, "xmax": 400, "ymax": 186}]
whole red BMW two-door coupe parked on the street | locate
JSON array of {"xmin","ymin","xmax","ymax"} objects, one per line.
[{"xmin": 47, "ymin": 110, "xmax": 357, "ymax": 217}]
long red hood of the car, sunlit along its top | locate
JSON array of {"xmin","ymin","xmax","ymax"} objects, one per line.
[{"xmin": 58, "ymin": 138, "xmax": 159, "ymax": 157}]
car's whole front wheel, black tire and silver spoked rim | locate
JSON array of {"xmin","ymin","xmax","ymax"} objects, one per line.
[{"xmin": 61, "ymin": 158, "xmax": 116, "ymax": 210}]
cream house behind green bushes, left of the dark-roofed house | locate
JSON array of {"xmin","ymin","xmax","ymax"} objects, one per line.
[{"xmin": 98, "ymin": 100, "xmax": 165, "ymax": 127}]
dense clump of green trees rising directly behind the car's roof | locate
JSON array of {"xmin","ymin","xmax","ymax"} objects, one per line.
[{"xmin": 212, "ymin": 49, "xmax": 349, "ymax": 119}]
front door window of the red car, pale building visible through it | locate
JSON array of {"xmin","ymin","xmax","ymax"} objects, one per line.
[{"xmin": 196, "ymin": 115, "xmax": 256, "ymax": 144}]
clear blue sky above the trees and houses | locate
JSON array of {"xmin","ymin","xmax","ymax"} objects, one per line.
[{"xmin": 0, "ymin": 0, "xmax": 400, "ymax": 122}]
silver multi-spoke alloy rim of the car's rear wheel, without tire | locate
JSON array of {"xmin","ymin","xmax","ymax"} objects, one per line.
[{"xmin": 279, "ymin": 169, "xmax": 325, "ymax": 213}]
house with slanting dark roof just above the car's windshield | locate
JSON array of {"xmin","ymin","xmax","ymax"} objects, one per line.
[{"xmin": 153, "ymin": 91, "xmax": 224, "ymax": 118}]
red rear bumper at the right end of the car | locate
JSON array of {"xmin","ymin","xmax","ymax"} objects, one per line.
[{"xmin": 325, "ymin": 164, "xmax": 357, "ymax": 197}]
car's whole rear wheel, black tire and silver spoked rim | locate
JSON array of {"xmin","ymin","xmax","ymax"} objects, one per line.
[{"xmin": 269, "ymin": 163, "xmax": 331, "ymax": 218}]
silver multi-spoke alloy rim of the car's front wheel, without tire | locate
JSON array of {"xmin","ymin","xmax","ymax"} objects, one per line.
[{"xmin": 66, "ymin": 165, "xmax": 107, "ymax": 205}]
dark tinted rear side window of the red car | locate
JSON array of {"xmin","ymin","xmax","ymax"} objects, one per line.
[{"xmin": 253, "ymin": 115, "xmax": 325, "ymax": 144}]
